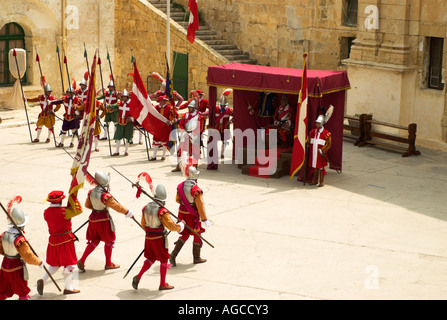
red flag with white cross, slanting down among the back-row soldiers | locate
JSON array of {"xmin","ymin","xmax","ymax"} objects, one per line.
[{"xmin": 129, "ymin": 61, "xmax": 171, "ymax": 141}]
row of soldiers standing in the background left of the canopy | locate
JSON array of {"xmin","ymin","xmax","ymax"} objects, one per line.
[{"xmin": 20, "ymin": 72, "xmax": 233, "ymax": 164}]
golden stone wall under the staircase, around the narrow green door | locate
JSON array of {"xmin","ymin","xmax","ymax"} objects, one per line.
[{"xmin": 115, "ymin": 0, "xmax": 228, "ymax": 99}]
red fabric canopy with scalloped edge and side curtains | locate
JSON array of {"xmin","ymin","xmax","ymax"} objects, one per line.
[{"xmin": 207, "ymin": 63, "xmax": 350, "ymax": 178}]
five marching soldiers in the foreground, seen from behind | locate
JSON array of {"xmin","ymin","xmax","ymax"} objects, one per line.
[{"xmin": 0, "ymin": 161, "xmax": 212, "ymax": 300}]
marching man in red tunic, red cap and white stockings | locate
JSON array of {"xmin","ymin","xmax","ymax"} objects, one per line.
[{"xmin": 37, "ymin": 190, "xmax": 81, "ymax": 295}]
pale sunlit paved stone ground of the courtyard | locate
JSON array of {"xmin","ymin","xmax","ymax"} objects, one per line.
[{"xmin": 0, "ymin": 108, "xmax": 447, "ymax": 300}]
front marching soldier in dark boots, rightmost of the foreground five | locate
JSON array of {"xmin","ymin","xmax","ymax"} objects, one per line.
[{"xmin": 169, "ymin": 165, "xmax": 211, "ymax": 267}]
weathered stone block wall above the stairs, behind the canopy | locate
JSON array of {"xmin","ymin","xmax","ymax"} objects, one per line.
[{"xmin": 176, "ymin": 0, "xmax": 356, "ymax": 70}]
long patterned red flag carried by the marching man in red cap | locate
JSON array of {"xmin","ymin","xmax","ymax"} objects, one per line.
[{"xmin": 66, "ymin": 56, "xmax": 96, "ymax": 217}]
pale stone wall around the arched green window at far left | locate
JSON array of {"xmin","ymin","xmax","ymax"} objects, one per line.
[{"xmin": 0, "ymin": 0, "xmax": 115, "ymax": 107}]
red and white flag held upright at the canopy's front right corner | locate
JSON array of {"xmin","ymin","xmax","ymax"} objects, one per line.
[{"xmin": 290, "ymin": 53, "xmax": 308, "ymax": 179}]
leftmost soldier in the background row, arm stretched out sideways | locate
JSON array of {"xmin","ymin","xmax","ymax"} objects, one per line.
[{"xmin": 26, "ymin": 83, "xmax": 59, "ymax": 143}]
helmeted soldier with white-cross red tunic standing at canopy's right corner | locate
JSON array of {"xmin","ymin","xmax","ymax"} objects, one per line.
[{"xmin": 308, "ymin": 115, "xmax": 332, "ymax": 187}]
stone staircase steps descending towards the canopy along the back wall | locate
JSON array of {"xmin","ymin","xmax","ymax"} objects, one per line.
[{"xmin": 149, "ymin": 0, "xmax": 258, "ymax": 64}]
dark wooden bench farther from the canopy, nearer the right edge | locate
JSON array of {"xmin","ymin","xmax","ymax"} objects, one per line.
[{"xmin": 358, "ymin": 114, "xmax": 421, "ymax": 157}]
